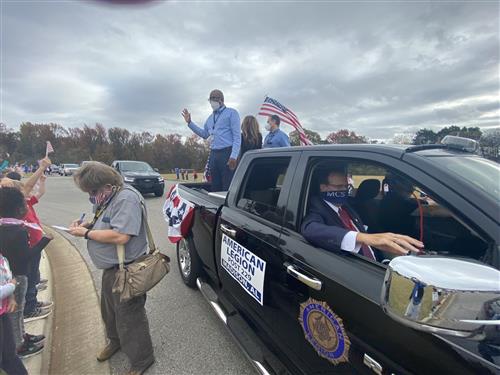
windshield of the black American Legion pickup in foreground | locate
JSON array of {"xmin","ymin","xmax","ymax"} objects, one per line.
[{"xmin": 433, "ymin": 156, "xmax": 500, "ymax": 200}]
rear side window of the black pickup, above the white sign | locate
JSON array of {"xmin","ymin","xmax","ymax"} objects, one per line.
[{"xmin": 236, "ymin": 158, "xmax": 290, "ymax": 224}]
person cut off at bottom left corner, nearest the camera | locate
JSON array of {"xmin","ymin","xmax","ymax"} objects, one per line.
[{"xmin": 0, "ymin": 254, "xmax": 28, "ymax": 375}]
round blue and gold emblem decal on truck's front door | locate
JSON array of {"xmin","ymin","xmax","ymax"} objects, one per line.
[{"xmin": 299, "ymin": 298, "xmax": 351, "ymax": 365}]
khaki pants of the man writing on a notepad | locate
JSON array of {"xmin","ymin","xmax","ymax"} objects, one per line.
[{"xmin": 101, "ymin": 269, "xmax": 154, "ymax": 370}]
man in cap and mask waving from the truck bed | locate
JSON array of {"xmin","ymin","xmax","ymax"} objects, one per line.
[{"xmin": 182, "ymin": 90, "xmax": 241, "ymax": 191}]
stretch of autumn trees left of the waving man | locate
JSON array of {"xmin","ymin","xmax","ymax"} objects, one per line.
[{"xmin": 0, "ymin": 122, "xmax": 209, "ymax": 172}]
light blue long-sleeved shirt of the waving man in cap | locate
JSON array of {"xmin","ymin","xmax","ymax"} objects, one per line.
[{"xmin": 188, "ymin": 106, "xmax": 241, "ymax": 159}]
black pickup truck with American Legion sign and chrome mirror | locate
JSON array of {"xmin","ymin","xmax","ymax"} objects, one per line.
[{"xmin": 177, "ymin": 138, "xmax": 500, "ymax": 374}]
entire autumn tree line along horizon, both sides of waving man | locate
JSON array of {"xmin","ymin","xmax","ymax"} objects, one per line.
[{"xmin": 0, "ymin": 122, "xmax": 500, "ymax": 172}]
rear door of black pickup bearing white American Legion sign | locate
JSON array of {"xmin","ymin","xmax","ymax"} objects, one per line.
[{"xmin": 216, "ymin": 152, "xmax": 300, "ymax": 358}]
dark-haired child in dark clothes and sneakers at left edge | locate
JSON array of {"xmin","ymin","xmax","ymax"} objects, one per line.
[{"xmin": 0, "ymin": 188, "xmax": 45, "ymax": 358}]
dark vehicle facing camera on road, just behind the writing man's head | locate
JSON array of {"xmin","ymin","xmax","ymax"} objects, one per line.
[{"xmin": 111, "ymin": 160, "xmax": 165, "ymax": 197}]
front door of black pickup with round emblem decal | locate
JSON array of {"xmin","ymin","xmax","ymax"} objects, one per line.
[{"xmin": 258, "ymin": 151, "xmax": 496, "ymax": 374}]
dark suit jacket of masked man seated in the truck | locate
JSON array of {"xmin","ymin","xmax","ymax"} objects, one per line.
[{"xmin": 300, "ymin": 196, "xmax": 365, "ymax": 252}]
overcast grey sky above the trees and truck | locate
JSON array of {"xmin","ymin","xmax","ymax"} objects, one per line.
[{"xmin": 0, "ymin": 0, "xmax": 500, "ymax": 138}]
